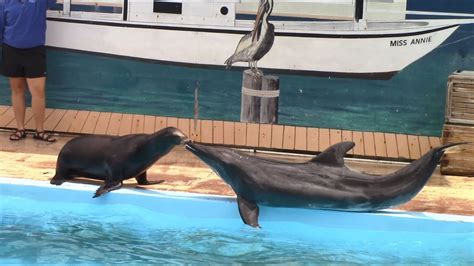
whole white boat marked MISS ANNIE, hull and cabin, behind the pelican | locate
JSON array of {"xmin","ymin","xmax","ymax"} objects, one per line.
[{"xmin": 47, "ymin": 0, "xmax": 474, "ymax": 79}]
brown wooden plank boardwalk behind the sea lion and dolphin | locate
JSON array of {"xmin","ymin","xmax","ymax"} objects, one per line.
[{"xmin": 0, "ymin": 105, "xmax": 441, "ymax": 160}]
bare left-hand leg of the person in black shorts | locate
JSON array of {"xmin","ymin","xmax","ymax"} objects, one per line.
[{"xmin": 9, "ymin": 77, "xmax": 26, "ymax": 130}]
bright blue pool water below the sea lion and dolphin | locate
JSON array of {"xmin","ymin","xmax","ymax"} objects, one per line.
[{"xmin": 0, "ymin": 180, "xmax": 474, "ymax": 265}]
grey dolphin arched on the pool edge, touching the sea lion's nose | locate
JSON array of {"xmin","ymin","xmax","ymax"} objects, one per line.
[{"xmin": 186, "ymin": 142, "xmax": 463, "ymax": 227}]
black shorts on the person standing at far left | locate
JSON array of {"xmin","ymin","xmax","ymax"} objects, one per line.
[{"xmin": 2, "ymin": 44, "xmax": 46, "ymax": 78}]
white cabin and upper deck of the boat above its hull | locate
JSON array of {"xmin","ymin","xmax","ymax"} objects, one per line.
[{"xmin": 48, "ymin": 0, "xmax": 474, "ymax": 31}]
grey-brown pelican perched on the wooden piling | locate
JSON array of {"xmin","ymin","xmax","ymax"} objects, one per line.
[{"xmin": 225, "ymin": 0, "xmax": 275, "ymax": 72}]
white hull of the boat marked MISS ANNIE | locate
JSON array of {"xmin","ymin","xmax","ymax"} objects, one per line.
[{"xmin": 47, "ymin": 18, "xmax": 459, "ymax": 79}]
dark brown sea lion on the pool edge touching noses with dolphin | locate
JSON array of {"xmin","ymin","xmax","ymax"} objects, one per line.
[{"xmin": 51, "ymin": 127, "xmax": 187, "ymax": 198}]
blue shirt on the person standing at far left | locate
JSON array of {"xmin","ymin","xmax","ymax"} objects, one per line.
[{"xmin": 0, "ymin": 0, "xmax": 56, "ymax": 49}]
